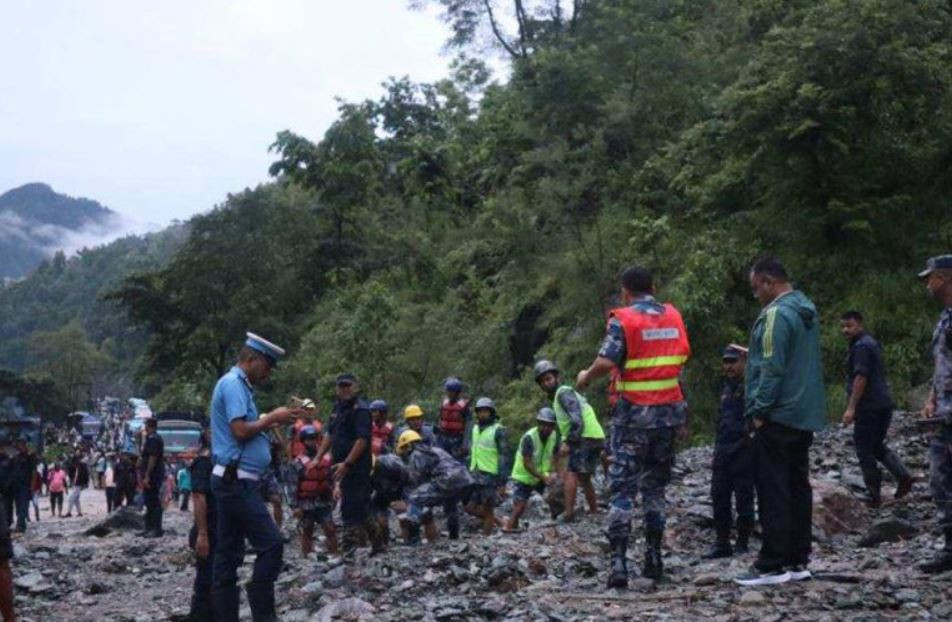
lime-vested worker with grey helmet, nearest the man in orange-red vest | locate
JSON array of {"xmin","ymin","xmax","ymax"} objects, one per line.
[{"xmin": 533, "ymin": 359, "xmax": 605, "ymax": 522}]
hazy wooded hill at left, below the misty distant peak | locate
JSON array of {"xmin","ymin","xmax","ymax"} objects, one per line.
[{"xmin": 0, "ymin": 225, "xmax": 188, "ymax": 416}]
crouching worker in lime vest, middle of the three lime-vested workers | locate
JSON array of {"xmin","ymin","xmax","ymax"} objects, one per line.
[{"xmin": 506, "ymin": 408, "xmax": 559, "ymax": 531}]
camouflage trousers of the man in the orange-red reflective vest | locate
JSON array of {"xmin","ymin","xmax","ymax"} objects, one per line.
[{"xmin": 608, "ymin": 424, "xmax": 677, "ymax": 539}]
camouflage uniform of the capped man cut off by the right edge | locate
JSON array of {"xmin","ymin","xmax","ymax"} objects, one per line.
[{"xmin": 929, "ymin": 308, "xmax": 952, "ymax": 533}]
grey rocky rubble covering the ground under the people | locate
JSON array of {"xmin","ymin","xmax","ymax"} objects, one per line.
[{"xmin": 14, "ymin": 417, "xmax": 952, "ymax": 622}]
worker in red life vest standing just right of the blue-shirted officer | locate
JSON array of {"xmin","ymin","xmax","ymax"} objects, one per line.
[{"xmin": 291, "ymin": 426, "xmax": 337, "ymax": 557}]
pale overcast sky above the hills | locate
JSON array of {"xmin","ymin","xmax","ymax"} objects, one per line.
[{"xmin": 0, "ymin": 0, "xmax": 458, "ymax": 232}]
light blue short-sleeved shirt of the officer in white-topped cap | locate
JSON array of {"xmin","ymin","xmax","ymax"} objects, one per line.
[{"xmin": 211, "ymin": 367, "xmax": 271, "ymax": 474}]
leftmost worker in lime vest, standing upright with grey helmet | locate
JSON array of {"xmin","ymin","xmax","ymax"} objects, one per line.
[{"xmin": 466, "ymin": 397, "xmax": 511, "ymax": 535}]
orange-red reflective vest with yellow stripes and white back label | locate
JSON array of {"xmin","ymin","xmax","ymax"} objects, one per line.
[{"xmin": 612, "ymin": 304, "xmax": 691, "ymax": 406}]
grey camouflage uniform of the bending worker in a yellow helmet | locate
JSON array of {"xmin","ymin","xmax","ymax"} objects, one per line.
[{"xmin": 407, "ymin": 443, "xmax": 475, "ymax": 533}]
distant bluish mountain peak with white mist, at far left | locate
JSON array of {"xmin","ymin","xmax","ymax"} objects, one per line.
[{"xmin": 0, "ymin": 183, "xmax": 120, "ymax": 280}]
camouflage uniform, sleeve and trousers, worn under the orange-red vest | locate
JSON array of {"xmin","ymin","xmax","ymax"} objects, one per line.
[{"xmin": 598, "ymin": 296, "xmax": 687, "ymax": 539}]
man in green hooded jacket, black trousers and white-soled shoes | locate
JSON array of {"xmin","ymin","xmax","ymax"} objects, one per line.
[{"xmin": 734, "ymin": 257, "xmax": 826, "ymax": 585}]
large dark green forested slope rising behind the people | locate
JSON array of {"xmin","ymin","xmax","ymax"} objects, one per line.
[{"xmin": 31, "ymin": 0, "xmax": 952, "ymax": 432}]
